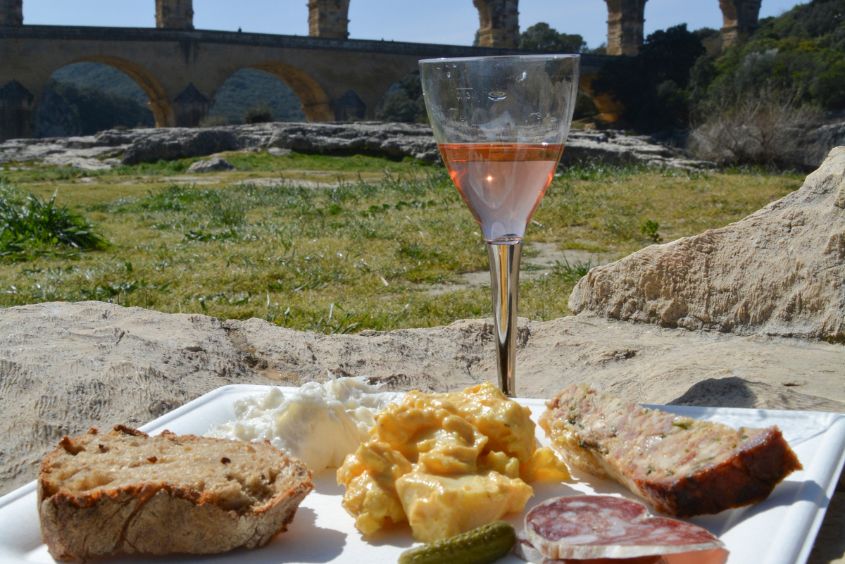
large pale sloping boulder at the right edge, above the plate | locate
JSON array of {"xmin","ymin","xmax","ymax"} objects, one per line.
[{"xmin": 569, "ymin": 147, "xmax": 845, "ymax": 340}]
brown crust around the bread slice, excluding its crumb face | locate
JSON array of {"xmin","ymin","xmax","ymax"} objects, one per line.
[{"xmin": 38, "ymin": 426, "xmax": 313, "ymax": 560}]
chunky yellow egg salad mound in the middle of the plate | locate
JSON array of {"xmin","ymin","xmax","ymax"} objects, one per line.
[{"xmin": 337, "ymin": 383, "xmax": 569, "ymax": 542}]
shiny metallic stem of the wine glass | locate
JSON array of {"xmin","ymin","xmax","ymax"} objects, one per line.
[{"xmin": 487, "ymin": 241, "xmax": 522, "ymax": 397}]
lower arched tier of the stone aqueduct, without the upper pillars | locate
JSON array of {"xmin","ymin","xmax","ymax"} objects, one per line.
[{"xmin": 0, "ymin": 25, "xmax": 606, "ymax": 139}]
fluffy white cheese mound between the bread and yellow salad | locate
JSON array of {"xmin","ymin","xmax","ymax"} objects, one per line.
[{"xmin": 207, "ymin": 378, "xmax": 399, "ymax": 473}]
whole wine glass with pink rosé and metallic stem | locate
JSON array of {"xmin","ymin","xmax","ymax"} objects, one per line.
[{"xmin": 419, "ymin": 55, "xmax": 579, "ymax": 396}]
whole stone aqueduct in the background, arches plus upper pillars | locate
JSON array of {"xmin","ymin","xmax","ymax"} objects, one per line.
[{"xmin": 0, "ymin": 0, "xmax": 761, "ymax": 140}]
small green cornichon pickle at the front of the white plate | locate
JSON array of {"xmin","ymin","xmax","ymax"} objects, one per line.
[{"xmin": 399, "ymin": 521, "xmax": 516, "ymax": 564}]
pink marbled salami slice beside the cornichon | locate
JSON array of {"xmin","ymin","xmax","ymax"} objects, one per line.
[{"xmin": 524, "ymin": 495, "xmax": 727, "ymax": 562}]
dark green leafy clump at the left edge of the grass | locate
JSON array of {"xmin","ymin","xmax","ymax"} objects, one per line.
[{"xmin": 0, "ymin": 185, "xmax": 108, "ymax": 260}]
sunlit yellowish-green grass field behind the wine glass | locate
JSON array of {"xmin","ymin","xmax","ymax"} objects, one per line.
[{"xmin": 0, "ymin": 153, "xmax": 802, "ymax": 333}]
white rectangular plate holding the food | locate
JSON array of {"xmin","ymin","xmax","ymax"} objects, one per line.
[{"xmin": 0, "ymin": 385, "xmax": 845, "ymax": 564}]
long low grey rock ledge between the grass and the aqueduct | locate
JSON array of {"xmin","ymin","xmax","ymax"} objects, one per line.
[{"xmin": 0, "ymin": 122, "xmax": 710, "ymax": 168}]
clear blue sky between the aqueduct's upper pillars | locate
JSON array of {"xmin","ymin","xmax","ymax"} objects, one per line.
[{"xmin": 23, "ymin": 0, "xmax": 802, "ymax": 47}]
